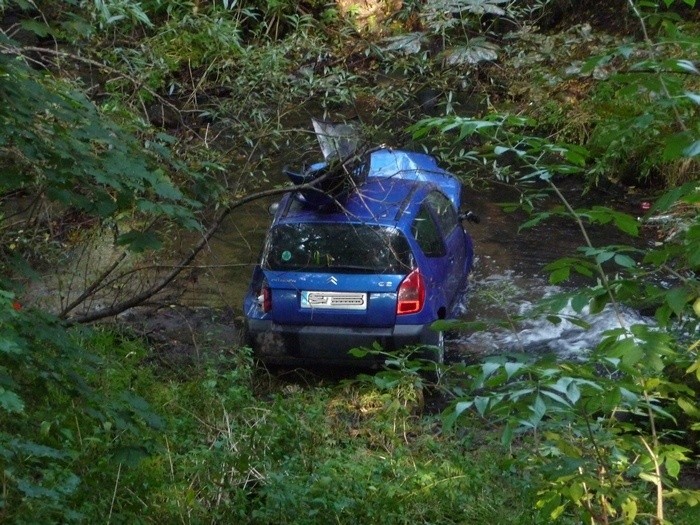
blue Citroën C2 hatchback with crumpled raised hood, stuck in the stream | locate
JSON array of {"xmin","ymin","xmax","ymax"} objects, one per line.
[{"xmin": 244, "ymin": 149, "xmax": 474, "ymax": 364}]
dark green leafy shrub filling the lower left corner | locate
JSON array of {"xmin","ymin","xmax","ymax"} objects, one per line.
[{"xmin": 0, "ymin": 292, "xmax": 163, "ymax": 523}]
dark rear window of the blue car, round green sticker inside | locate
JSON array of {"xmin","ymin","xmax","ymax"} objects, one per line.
[{"xmin": 263, "ymin": 223, "xmax": 412, "ymax": 274}]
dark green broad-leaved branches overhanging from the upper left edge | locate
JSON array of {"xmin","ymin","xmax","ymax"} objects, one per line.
[{"xmin": 0, "ymin": 48, "xmax": 205, "ymax": 260}]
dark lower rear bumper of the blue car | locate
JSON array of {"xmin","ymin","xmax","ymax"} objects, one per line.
[{"xmin": 246, "ymin": 319, "xmax": 437, "ymax": 366}]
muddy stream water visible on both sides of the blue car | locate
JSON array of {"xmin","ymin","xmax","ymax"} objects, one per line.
[{"xmin": 185, "ymin": 175, "xmax": 644, "ymax": 360}]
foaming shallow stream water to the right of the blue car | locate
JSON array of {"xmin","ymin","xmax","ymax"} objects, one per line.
[{"xmin": 448, "ymin": 181, "xmax": 649, "ymax": 360}]
